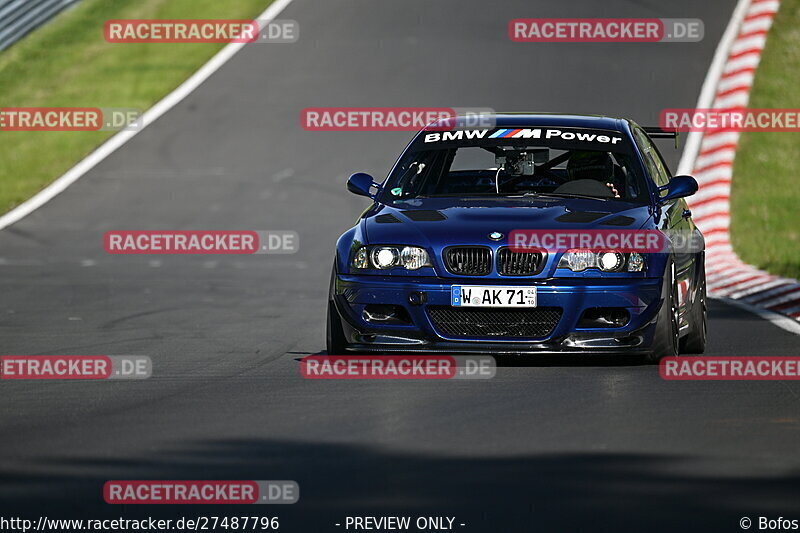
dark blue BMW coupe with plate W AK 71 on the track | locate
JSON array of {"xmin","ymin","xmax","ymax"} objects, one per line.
[{"xmin": 327, "ymin": 114, "xmax": 706, "ymax": 361}]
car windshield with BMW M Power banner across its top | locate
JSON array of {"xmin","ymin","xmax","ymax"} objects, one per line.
[{"xmin": 381, "ymin": 128, "xmax": 646, "ymax": 203}]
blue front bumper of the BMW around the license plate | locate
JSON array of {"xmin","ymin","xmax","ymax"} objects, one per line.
[{"xmin": 332, "ymin": 274, "xmax": 662, "ymax": 354}]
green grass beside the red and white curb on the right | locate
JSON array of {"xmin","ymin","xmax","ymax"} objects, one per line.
[{"xmin": 731, "ymin": 0, "xmax": 800, "ymax": 278}]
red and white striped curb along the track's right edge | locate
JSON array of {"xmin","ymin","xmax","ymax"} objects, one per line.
[{"xmin": 678, "ymin": 0, "xmax": 800, "ymax": 320}]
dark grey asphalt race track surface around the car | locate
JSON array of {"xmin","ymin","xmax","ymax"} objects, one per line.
[{"xmin": 0, "ymin": 0, "xmax": 800, "ymax": 531}]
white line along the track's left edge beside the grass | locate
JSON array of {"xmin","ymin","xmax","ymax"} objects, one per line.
[{"xmin": 0, "ymin": 0, "xmax": 292, "ymax": 230}]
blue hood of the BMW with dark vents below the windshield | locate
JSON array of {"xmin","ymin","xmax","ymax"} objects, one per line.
[{"xmin": 363, "ymin": 197, "xmax": 651, "ymax": 246}]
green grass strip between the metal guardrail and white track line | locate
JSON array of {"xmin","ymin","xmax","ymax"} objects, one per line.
[{"xmin": 0, "ymin": 0, "xmax": 271, "ymax": 213}]
